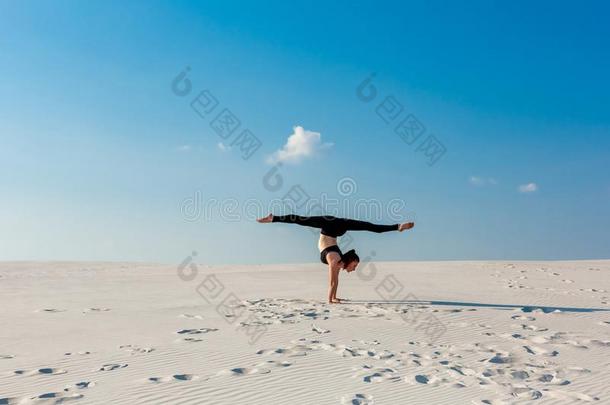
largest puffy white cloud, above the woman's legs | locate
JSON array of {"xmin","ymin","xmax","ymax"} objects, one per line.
[{"xmin": 267, "ymin": 126, "xmax": 333, "ymax": 164}]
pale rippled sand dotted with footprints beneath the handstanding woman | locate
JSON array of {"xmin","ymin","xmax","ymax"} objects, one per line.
[{"xmin": 0, "ymin": 261, "xmax": 610, "ymax": 404}]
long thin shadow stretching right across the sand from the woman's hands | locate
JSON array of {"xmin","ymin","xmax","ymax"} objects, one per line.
[{"xmin": 344, "ymin": 299, "xmax": 610, "ymax": 314}]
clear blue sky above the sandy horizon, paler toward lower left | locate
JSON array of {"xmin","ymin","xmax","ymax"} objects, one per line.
[{"xmin": 0, "ymin": 1, "xmax": 610, "ymax": 264}]
